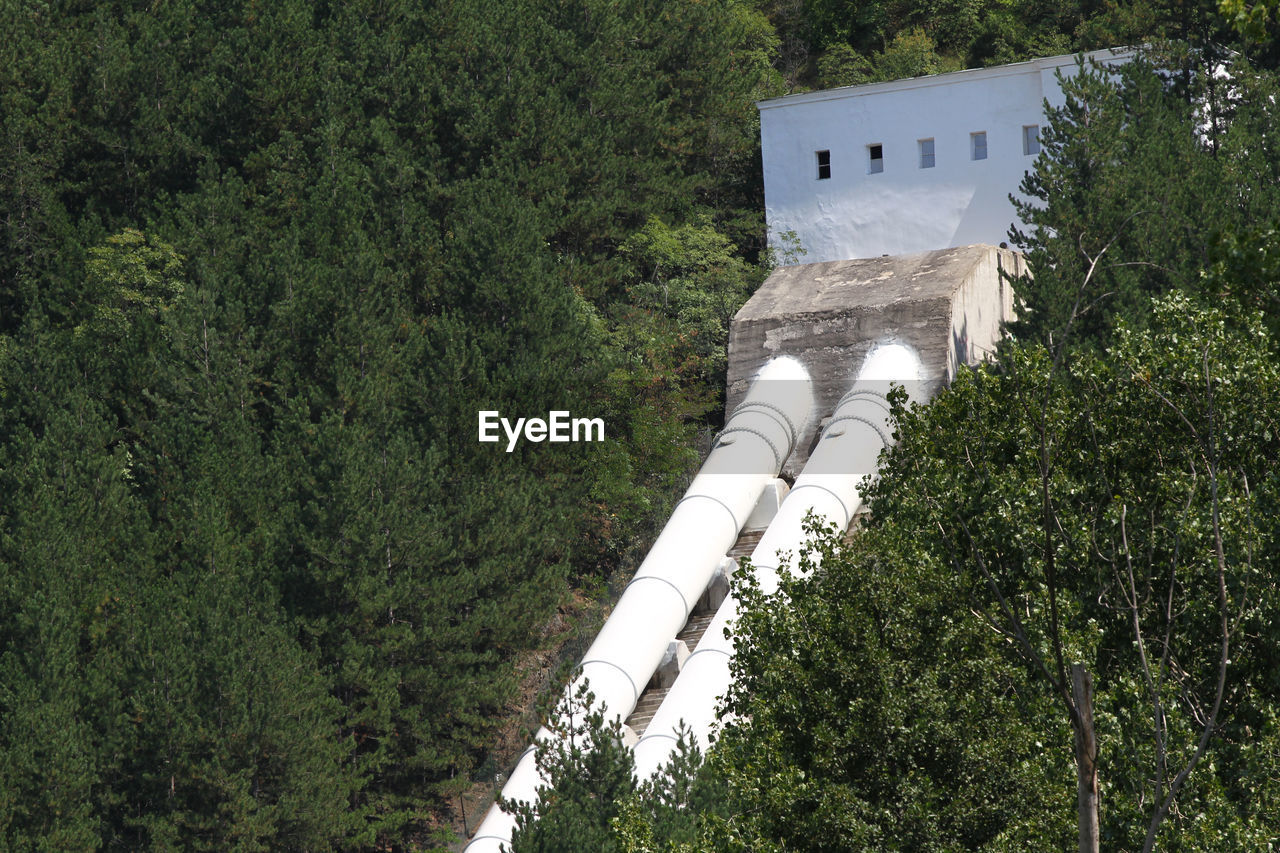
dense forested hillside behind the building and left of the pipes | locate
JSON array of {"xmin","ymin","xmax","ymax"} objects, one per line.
[{"xmin": 0, "ymin": 0, "xmax": 1280, "ymax": 850}]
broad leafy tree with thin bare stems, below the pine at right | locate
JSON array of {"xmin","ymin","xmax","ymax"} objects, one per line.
[{"xmin": 876, "ymin": 298, "xmax": 1277, "ymax": 849}]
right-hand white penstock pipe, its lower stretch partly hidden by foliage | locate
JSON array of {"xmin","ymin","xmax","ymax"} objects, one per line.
[{"xmin": 635, "ymin": 343, "xmax": 923, "ymax": 780}]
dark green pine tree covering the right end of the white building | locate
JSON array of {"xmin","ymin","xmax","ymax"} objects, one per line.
[{"xmin": 1011, "ymin": 53, "xmax": 1280, "ymax": 350}]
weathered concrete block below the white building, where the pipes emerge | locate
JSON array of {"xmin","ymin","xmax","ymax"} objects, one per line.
[{"xmin": 727, "ymin": 246, "xmax": 1025, "ymax": 478}]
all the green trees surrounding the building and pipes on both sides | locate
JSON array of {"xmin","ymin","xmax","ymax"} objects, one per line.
[{"xmin": 0, "ymin": 0, "xmax": 1280, "ymax": 853}]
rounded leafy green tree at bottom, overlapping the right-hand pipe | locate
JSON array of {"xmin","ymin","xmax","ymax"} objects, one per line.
[{"xmin": 717, "ymin": 524, "xmax": 1070, "ymax": 850}]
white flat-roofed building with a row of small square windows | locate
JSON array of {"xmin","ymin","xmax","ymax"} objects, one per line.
[{"xmin": 756, "ymin": 50, "xmax": 1132, "ymax": 264}]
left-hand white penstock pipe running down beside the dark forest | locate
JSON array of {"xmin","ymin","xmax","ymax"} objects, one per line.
[{"xmin": 466, "ymin": 356, "xmax": 813, "ymax": 853}]
